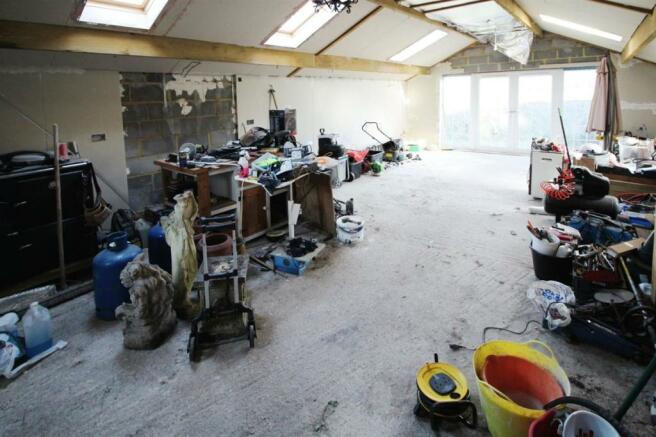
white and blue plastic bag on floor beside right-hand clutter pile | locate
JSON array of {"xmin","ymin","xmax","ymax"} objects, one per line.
[{"xmin": 526, "ymin": 281, "xmax": 576, "ymax": 330}]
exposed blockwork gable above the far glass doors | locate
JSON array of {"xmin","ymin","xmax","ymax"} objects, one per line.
[{"xmin": 446, "ymin": 33, "xmax": 605, "ymax": 74}]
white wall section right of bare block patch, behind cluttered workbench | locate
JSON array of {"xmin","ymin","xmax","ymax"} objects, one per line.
[{"xmin": 237, "ymin": 76, "xmax": 406, "ymax": 149}]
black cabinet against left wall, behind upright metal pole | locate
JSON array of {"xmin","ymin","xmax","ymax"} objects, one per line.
[{"xmin": 0, "ymin": 160, "xmax": 98, "ymax": 286}]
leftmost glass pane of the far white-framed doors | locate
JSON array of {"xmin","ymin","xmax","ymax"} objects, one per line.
[{"xmin": 440, "ymin": 76, "xmax": 471, "ymax": 149}]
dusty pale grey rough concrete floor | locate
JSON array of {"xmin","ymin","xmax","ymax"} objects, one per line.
[{"xmin": 0, "ymin": 152, "xmax": 656, "ymax": 436}]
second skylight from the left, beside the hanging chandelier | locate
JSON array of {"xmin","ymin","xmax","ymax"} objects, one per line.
[{"xmin": 264, "ymin": 0, "xmax": 337, "ymax": 49}]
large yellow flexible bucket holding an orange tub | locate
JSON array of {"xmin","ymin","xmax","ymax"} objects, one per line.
[{"xmin": 473, "ymin": 340, "xmax": 571, "ymax": 437}]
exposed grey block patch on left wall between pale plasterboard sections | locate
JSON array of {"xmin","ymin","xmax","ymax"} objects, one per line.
[{"xmin": 121, "ymin": 73, "xmax": 237, "ymax": 211}]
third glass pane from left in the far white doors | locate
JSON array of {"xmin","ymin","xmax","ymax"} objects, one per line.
[{"xmin": 516, "ymin": 74, "xmax": 553, "ymax": 150}]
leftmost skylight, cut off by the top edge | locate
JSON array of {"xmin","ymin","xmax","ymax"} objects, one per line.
[{"xmin": 78, "ymin": 0, "xmax": 168, "ymax": 29}]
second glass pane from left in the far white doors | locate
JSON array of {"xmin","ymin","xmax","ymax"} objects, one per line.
[{"xmin": 478, "ymin": 76, "xmax": 511, "ymax": 150}]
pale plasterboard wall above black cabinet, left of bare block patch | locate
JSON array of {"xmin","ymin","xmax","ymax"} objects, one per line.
[{"xmin": 0, "ymin": 68, "xmax": 128, "ymax": 208}]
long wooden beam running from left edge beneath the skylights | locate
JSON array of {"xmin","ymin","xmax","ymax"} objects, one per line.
[{"xmin": 0, "ymin": 21, "xmax": 430, "ymax": 74}]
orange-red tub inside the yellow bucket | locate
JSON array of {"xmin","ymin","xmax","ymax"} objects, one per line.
[{"xmin": 483, "ymin": 355, "xmax": 564, "ymax": 410}]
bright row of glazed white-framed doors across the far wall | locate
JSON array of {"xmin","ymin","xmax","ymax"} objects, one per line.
[{"xmin": 440, "ymin": 68, "xmax": 596, "ymax": 151}]
